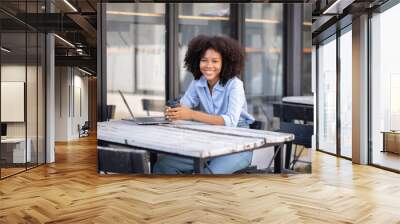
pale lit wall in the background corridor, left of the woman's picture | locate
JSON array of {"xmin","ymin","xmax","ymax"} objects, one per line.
[{"xmin": 55, "ymin": 67, "xmax": 88, "ymax": 141}]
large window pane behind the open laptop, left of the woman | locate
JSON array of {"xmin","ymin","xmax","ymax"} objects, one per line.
[{"xmin": 105, "ymin": 3, "xmax": 166, "ymax": 119}]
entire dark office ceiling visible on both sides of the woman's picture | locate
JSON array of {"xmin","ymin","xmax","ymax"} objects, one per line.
[{"xmin": 0, "ymin": 0, "xmax": 394, "ymax": 73}]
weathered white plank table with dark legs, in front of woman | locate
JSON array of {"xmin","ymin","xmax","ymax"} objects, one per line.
[{"xmin": 97, "ymin": 121, "xmax": 294, "ymax": 173}]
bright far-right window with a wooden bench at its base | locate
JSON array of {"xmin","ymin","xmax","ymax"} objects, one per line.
[{"xmin": 370, "ymin": 4, "xmax": 400, "ymax": 170}]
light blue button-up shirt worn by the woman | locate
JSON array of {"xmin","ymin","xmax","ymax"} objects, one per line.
[{"xmin": 180, "ymin": 76, "xmax": 254, "ymax": 127}]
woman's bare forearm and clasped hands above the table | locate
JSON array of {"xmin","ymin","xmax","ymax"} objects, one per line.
[{"xmin": 165, "ymin": 106, "xmax": 225, "ymax": 125}]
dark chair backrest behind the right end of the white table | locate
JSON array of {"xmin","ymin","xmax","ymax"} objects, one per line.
[{"xmin": 279, "ymin": 121, "xmax": 314, "ymax": 148}]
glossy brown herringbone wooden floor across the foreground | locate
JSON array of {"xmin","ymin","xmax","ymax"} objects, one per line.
[{"xmin": 0, "ymin": 138, "xmax": 400, "ymax": 224}]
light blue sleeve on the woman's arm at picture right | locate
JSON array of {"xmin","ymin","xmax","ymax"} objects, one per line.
[{"xmin": 221, "ymin": 82, "xmax": 246, "ymax": 127}]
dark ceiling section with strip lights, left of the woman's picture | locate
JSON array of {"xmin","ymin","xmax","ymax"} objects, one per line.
[{"xmin": 0, "ymin": 0, "xmax": 101, "ymax": 74}]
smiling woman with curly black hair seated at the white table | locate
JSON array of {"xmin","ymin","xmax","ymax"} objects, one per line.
[{"xmin": 153, "ymin": 35, "xmax": 254, "ymax": 174}]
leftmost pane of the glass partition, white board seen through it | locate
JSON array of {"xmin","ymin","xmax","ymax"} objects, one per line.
[{"xmin": 0, "ymin": 32, "xmax": 27, "ymax": 177}]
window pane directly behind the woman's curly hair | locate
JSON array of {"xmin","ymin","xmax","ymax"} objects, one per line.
[{"xmin": 178, "ymin": 3, "xmax": 230, "ymax": 95}]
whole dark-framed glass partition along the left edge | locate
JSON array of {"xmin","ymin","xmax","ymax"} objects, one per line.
[{"xmin": 0, "ymin": 1, "xmax": 46, "ymax": 178}]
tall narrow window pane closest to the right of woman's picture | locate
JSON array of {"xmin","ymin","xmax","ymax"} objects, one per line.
[{"xmin": 317, "ymin": 36, "xmax": 336, "ymax": 154}]
